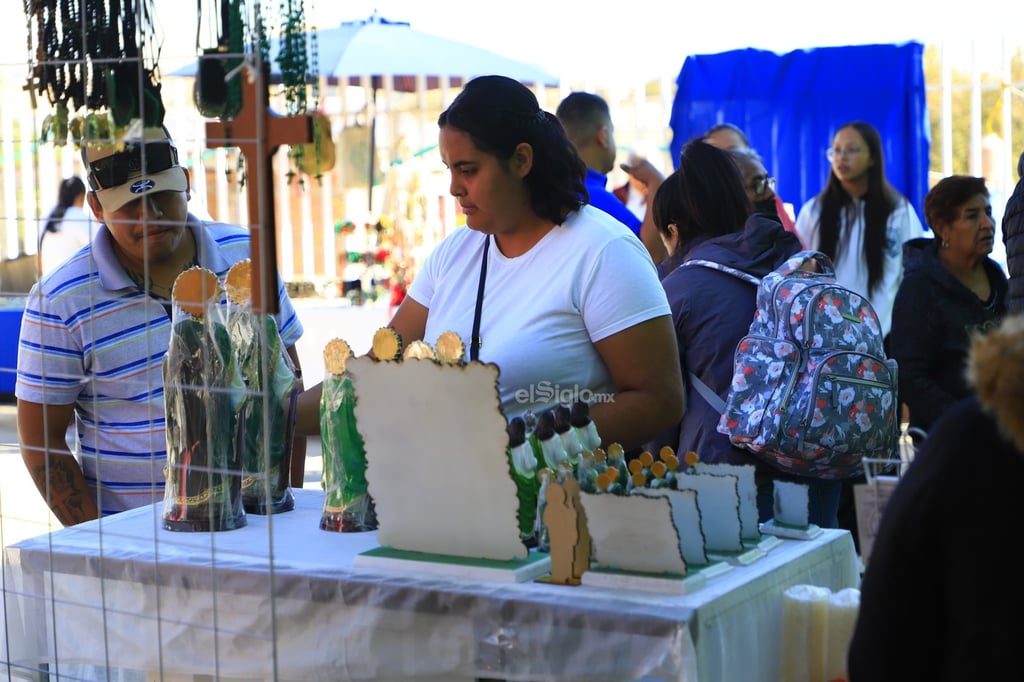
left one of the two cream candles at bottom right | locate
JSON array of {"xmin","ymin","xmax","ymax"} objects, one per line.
[{"xmin": 779, "ymin": 585, "xmax": 831, "ymax": 682}]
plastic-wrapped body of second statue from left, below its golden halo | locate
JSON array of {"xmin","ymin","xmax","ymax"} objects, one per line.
[{"xmin": 228, "ymin": 308, "xmax": 296, "ymax": 514}]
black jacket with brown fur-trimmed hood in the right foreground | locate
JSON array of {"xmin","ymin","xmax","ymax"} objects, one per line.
[{"xmin": 847, "ymin": 314, "xmax": 1024, "ymax": 682}]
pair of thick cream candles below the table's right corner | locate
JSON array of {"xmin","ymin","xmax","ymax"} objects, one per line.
[{"xmin": 779, "ymin": 585, "xmax": 860, "ymax": 682}]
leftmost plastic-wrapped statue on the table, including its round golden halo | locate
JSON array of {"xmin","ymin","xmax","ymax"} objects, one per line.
[{"xmin": 163, "ymin": 267, "xmax": 246, "ymax": 530}]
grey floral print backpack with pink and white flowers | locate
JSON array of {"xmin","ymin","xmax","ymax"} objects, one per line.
[{"xmin": 681, "ymin": 251, "xmax": 899, "ymax": 478}]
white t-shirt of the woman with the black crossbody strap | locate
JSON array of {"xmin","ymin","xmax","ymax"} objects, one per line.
[{"xmin": 409, "ymin": 205, "xmax": 670, "ymax": 419}]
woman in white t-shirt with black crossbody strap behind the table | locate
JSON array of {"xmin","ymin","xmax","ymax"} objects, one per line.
[{"xmin": 390, "ymin": 76, "xmax": 683, "ymax": 450}]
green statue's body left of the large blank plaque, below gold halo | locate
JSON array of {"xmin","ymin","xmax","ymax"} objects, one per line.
[{"xmin": 319, "ymin": 373, "xmax": 377, "ymax": 532}]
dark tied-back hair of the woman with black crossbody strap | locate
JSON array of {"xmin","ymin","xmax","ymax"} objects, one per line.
[{"xmin": 437, "ymin": 76, "xmax": 590, "ymax": 223}]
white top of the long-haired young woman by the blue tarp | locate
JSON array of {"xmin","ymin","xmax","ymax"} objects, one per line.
[{"xmin": 797, "ymin": 197, "xmax": 925, "ymax": 335}]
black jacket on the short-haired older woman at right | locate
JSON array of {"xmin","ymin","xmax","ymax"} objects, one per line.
[{"xmin": 889, "ymin": 239, "xmax": 1007, "ymax": 431}]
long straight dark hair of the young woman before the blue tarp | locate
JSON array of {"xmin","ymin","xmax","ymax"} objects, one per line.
[{"xmin": 818, "ymin": 121, "xmax": 899, "ymax": 292}]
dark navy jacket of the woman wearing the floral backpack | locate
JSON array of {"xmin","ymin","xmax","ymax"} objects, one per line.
[{"xmin": 647, "ymin": 215, "xmax": 801, "ymax": 472}]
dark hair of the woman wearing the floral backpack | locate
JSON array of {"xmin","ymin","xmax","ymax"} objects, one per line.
[{"xmin": 651, "ymin": 139, "xmax": 754, "ymax": 257}]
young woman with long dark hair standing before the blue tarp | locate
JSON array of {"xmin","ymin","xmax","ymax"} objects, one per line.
[{"xmin": 797, "ymin": 121, "xmax": 925, "ymax": 336}]
